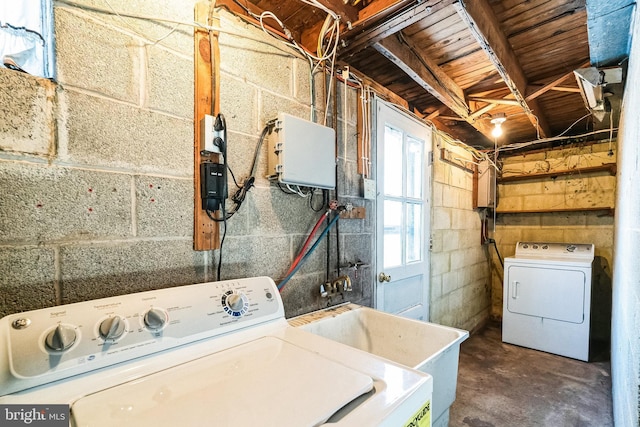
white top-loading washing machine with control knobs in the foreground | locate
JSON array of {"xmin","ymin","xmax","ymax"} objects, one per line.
[{"xmin": 0, "ymin": 277, "xmax": 433, "ymax": 427}]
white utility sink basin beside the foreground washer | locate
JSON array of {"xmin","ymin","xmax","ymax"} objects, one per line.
[{"xmin": 289, "ymin": 304, "xmax": 469, "ymax": 427}]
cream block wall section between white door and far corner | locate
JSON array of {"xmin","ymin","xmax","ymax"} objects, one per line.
[{"xmin": 431, "ymin": 132, "xmax": 491, "ymax": 331}]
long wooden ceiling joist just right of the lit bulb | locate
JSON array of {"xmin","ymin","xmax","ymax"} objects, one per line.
[{"xmin": 454, "ymin": 0, "xmax": 551, "ymax": 138}]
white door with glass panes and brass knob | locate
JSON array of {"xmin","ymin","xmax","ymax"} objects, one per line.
[{"xmin": 376, "ymin": 99, "xmax": 431, "ymax": 321}]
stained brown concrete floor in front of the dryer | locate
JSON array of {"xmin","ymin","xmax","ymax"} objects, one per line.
[{"xmin": 449, "ymin": 323, "xmax": 613, "ymax": 427}]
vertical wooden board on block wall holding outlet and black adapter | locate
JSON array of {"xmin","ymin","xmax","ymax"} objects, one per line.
[{"xmin": 193, "ymin": 1, "xmax": 220, "ymax": 251}]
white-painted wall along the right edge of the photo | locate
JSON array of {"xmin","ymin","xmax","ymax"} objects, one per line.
[{"xmin": 611, "ymin": 2, "xmax": 640, "ymax": 426}]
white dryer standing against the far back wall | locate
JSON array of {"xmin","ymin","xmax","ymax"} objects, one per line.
[{"xmin": 502, "ymin": 242, "xmax": 595, "ymax": 361}]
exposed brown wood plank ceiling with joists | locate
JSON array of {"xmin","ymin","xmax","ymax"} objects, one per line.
[{"xmin": 216, "ymin": 0, "xmax": 615, "ymax": 147}]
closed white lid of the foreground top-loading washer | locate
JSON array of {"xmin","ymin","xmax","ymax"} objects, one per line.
[{"xmin": 71, "ymin": 337, "xmax": 373, "ymax": 427}]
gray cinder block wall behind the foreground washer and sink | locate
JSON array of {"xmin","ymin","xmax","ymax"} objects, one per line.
[{"xmin": 0, "ymin": 0, "xmax": 373, "ymax": 316}]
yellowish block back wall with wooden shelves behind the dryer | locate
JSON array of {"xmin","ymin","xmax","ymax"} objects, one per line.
[{"xmin": 492, "ymin": 145, "xmax": 617, "ymax": 341}]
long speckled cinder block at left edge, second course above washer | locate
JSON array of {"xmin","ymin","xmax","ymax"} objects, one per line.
[{"xmin": 0, "ymin": 162, "xmax": 131, "ymax": 242}]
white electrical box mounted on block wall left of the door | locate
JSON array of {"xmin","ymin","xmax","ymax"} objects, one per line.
[{"xmin": 268, "ymin": 113, "xmax": 336, "ymax": 189}]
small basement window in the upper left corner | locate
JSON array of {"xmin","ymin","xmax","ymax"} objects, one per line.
[{"xmin": 0, "ymin": 0, "xmax": 54, "ymax": 78}]
